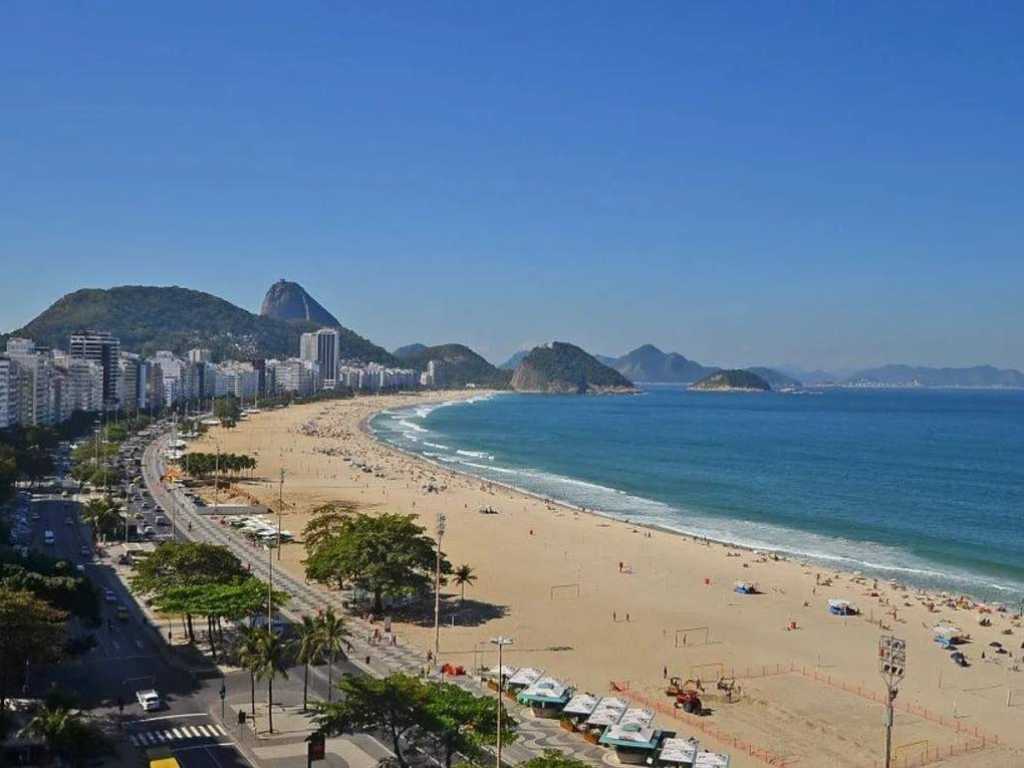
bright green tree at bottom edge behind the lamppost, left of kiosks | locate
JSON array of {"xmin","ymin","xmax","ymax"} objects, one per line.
[{"xmin": 422, "ymin": 683, "xmax": 516, "ymax": 768}]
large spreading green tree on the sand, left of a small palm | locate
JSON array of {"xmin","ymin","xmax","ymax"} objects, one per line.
[{"xmin": 305, "ymin": 513, "xmax": 452, "ymax": 611}]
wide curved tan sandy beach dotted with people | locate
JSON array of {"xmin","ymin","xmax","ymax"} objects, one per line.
[{"xmin": 190, "ymin": 391, "xmax": 1024, "ymax": 768}]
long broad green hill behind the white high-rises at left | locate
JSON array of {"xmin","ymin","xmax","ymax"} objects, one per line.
[{"xmin": 3, "ymin": 286, "xmax": 396, "ymax": 365}]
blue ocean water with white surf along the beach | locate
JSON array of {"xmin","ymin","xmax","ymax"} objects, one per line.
[{"xmin": 372, "ymin": 387, "xmax": 1024, "ymax": 603}]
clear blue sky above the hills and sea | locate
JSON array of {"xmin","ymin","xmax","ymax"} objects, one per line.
[{"xmin": 0, "ymin": 0, "xmax": 1024, "ymax": 368}]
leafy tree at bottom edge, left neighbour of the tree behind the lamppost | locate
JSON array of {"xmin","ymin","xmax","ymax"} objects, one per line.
[{"xmin": 313, "ymin": 674, "xmax": 429, "ymax": 768}]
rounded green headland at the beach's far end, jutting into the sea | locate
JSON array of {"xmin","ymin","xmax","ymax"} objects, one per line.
[{"xmin": 512, "ymin": 341, "xmax": 633, "ymax": 394}]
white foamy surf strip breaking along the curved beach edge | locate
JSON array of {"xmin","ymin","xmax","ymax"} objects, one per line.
[{"xmin": 358, "ymin": 390, "xmax": 1024, "ymax": 604}]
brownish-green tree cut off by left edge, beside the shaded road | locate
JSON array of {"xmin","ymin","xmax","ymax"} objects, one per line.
[{"xmin": 0, "ymin": 587, "xmax": 68, "ymax": 712}]
